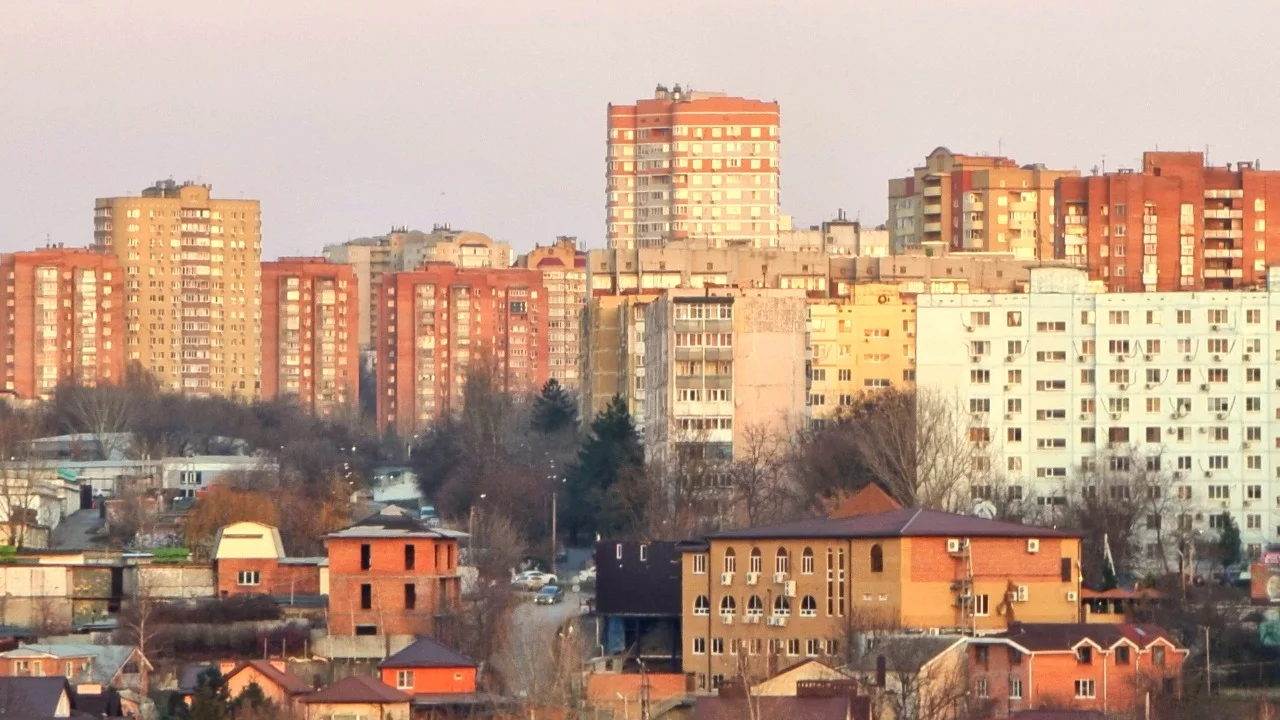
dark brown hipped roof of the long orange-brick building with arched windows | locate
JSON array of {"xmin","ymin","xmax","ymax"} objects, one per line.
[{"xmin": 710, "ymin": 509, "xmax": 1079, "ymax": 539}]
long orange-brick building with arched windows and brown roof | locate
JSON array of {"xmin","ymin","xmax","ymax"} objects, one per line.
[{"xmin": 681, "ymin": 510, "xmax": 1080, "ymax": 684}]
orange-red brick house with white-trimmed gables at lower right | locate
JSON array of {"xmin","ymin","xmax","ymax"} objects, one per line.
[{"xmin": 968, "ymin": 623, "xmax": 1189, "ymax": 717}]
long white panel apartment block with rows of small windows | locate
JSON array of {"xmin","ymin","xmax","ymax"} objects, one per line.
[{"xmin": 916, "ymin": 269, "xmax": 1280, "ymax": 557}]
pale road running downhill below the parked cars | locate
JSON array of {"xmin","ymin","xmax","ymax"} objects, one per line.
[{"xmin": 494, "ymin": 550, "xmax": 594, "ymax": 697}]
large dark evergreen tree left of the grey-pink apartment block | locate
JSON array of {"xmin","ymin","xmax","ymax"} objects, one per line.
[{"xmin": 567, "ymin": 396, "xmax": 644, "ymax": 541}]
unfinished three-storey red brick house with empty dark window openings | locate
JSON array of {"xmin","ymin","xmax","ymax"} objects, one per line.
[{"xmin": 326, "ymin": 506, "xmax": 462, "ymax": 635}]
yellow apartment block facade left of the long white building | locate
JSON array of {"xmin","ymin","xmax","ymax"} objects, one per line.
[{"xmin": 805, "ymin": 284, "xmax": 915, "ymax": 420}]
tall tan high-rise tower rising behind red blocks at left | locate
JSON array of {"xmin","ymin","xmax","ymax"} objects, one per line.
[{"xmin": 93, "ymin": 181, "xmax": 262, "ymax": 398}]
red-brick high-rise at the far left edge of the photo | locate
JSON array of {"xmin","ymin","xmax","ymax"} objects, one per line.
[{"xmin": 0, "ymin": 247, "xmax": 125, "ymax": 400}]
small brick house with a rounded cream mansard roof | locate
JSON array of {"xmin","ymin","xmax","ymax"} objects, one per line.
[{"xmin": 212, "ymin": 521, "xmax": 328, "ymax": 598}]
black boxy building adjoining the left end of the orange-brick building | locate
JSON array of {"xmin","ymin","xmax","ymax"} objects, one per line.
[{"xmin": 595, "ymin": 541, "xmax": 681, "ymax": 671}]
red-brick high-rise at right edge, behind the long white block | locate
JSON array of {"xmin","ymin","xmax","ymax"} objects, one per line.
[{"xmin": 1055, "ymin": 152, "xmax": 1280, "ymax": 291}]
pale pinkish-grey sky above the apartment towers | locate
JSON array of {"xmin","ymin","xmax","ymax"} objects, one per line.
[{"xmin": 0, "ymin": 0, "xmax": 1280, "ymax": 259}]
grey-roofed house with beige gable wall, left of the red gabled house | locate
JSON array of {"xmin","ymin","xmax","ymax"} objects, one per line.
[{"xmin": 841, "ymin": 633, "xmax": 969, "ymax": 720}]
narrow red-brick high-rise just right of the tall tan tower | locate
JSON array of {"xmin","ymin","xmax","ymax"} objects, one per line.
[{"xmin": 262, "ymin": 258, "xmax": 361, "ymax": 415}]
